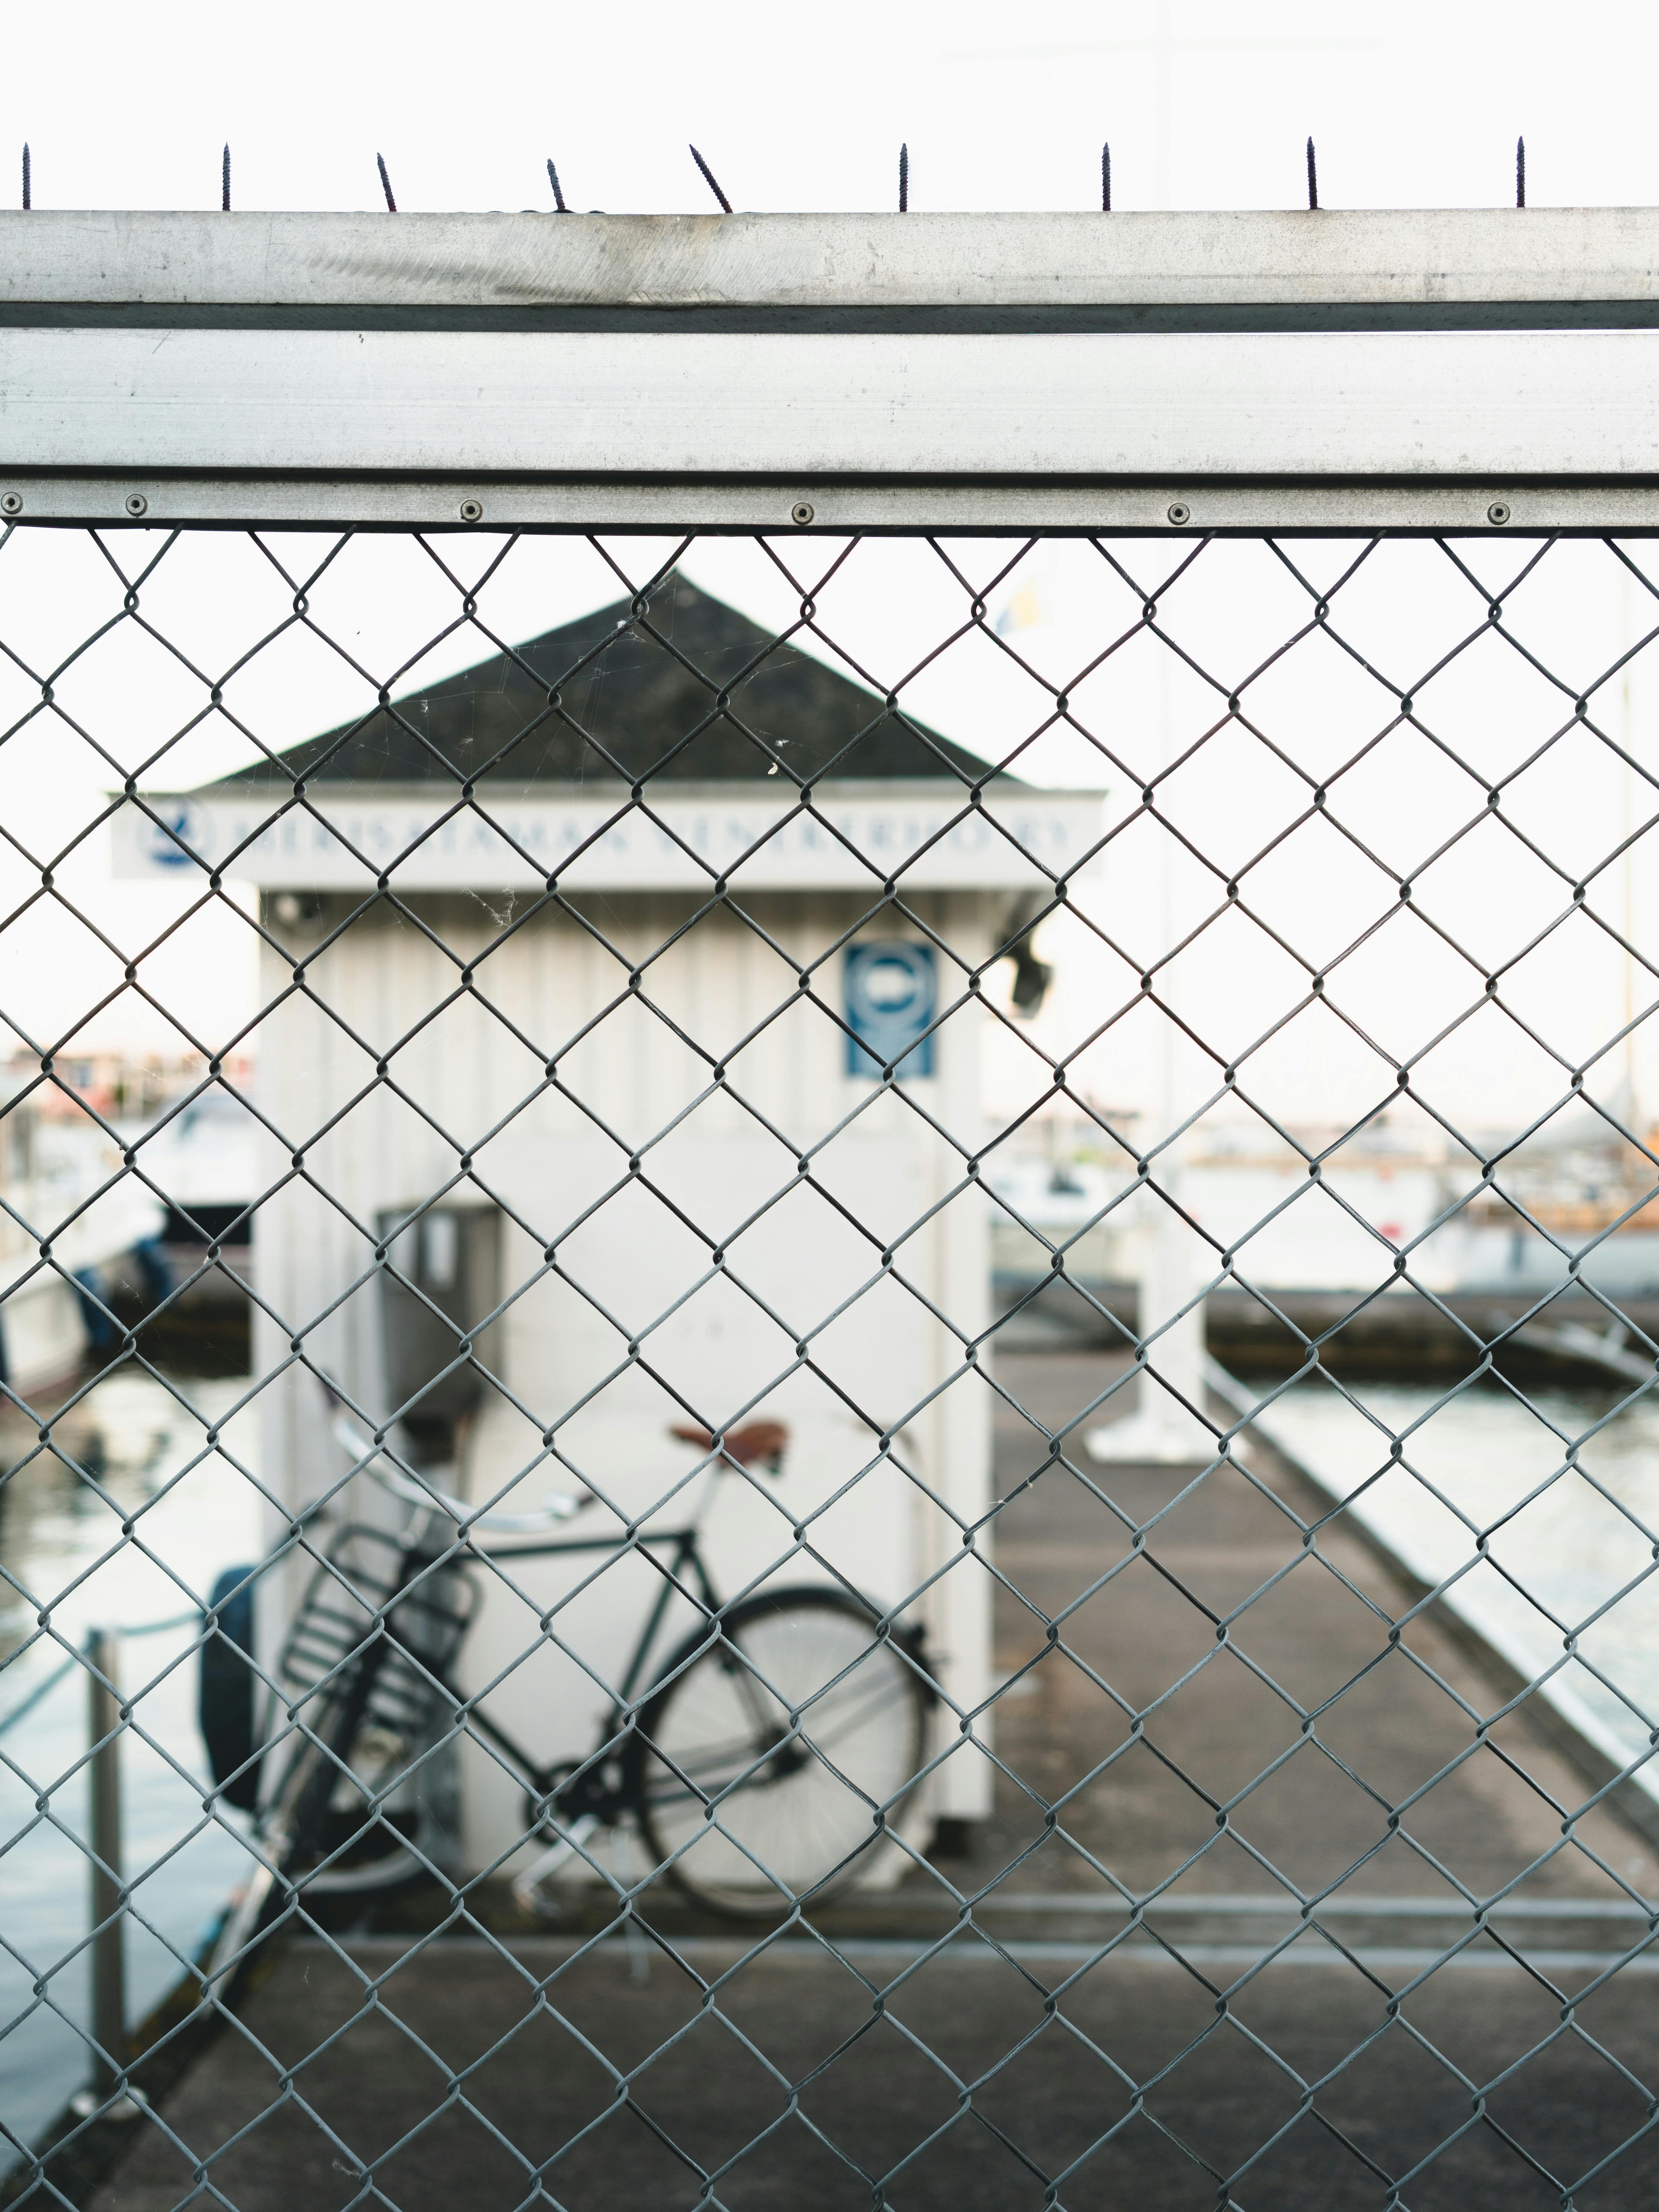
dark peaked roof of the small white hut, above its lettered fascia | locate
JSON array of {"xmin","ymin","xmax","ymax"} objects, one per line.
[{"xmin": 226, "ymin": 575, "xmax": 989, "ymax": 790}]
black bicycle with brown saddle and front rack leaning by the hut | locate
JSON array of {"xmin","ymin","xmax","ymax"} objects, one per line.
[{"xmin": 212, "ymin": 1400, "xmax": 938, "ymax": 1975}]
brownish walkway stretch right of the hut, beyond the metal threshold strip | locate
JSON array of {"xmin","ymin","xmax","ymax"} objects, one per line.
[{"xmin": 975, "ymin": 1354, "xmax": 1659, "ymax": 1898}]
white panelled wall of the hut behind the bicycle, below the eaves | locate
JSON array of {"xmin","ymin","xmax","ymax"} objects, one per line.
[{"xmin": 254, "ymin": 894, "xmax": 991, "ymax": 1867}]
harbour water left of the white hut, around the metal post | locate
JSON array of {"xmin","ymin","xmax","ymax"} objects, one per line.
[{"xmin": 0, "ymin": 1369, "xmax": 259, "ymax": 2163}]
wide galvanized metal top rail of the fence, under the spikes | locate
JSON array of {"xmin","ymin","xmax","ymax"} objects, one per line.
[{"xmin": 0, "ymin": 208, "xmax": 1659, "ymax": 533}]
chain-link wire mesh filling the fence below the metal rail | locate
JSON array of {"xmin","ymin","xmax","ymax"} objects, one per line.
[{"xmin": 0, "ymin": 529, "xmax": 1659, "ymax": 2212}]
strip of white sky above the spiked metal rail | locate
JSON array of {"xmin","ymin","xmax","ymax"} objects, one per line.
[{"xmin": 0, "ymin": 0, "xmax": 1659, "ymax": 212}]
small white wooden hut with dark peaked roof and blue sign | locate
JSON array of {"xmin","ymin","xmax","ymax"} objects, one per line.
[{"xmin": 122, "ymin": 577, "xmax": 1099, "ymax": 1867}]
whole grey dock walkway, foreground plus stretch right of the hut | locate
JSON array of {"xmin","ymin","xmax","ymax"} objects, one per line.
[{"xmin": 95, "ymin": 1356, "xmax": 1659, "ymax": 2212}]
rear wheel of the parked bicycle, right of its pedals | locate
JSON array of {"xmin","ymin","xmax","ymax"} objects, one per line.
[{"xmin": 633, "ymin": 1588, "xmax": 934, "ymax": 1918}]
